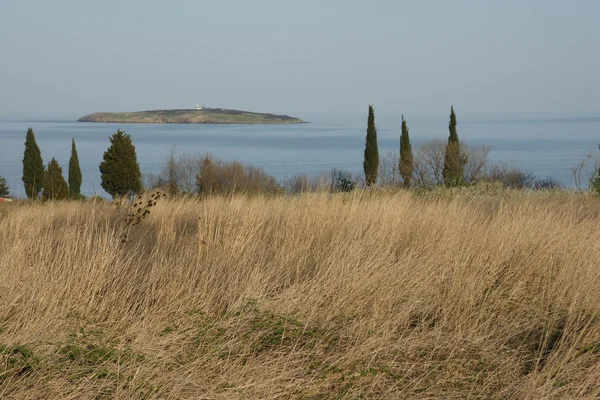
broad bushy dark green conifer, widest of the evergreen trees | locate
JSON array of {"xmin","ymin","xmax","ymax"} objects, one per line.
[{"xmin": 100, "ymin": 129, "xmax": 142, "ymax": 198}]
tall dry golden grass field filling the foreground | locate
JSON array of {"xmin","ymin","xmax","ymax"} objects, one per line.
[{"xmin": 0, "ymin": 190, "xmax": 600, "ymax": 399}]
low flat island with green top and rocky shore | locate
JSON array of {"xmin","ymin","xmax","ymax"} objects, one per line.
[{"xmin": 77, "ymin": 106, "xmax": 304, "ymax": 124}]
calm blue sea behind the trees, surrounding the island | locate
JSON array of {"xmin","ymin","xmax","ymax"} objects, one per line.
[{"xmin": 0, "ymin": 114, "xmax": 600, "ymax": 197}]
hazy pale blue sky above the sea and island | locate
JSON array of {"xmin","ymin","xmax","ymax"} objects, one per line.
[{"xmin": 0, "ymin": 0, "xmax": 600, "ymax": 118}]
